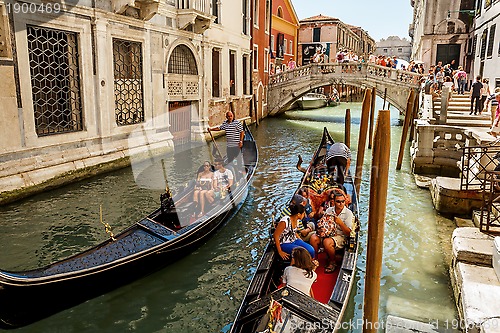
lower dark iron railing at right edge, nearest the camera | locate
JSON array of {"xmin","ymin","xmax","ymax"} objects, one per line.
[{"xmin": 479, "ymin": 171, "xmax": 500, "ymax": 234}]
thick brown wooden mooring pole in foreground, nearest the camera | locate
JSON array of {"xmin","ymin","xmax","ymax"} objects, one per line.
[{"xmin": 363, "ymin": 110, "xmax": 391, "ymax": 333}]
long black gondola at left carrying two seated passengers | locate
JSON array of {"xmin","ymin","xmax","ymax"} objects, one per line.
[{"xmin": 0, "ymin": 124, "xmax": 258, "ymax": 328}]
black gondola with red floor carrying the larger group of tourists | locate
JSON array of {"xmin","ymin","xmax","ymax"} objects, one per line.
[{"xmin": 231, "ymin": 128, "xmax": 359, "ymax": 333}]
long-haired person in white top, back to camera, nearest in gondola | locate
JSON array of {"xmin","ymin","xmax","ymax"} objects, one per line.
[{"xmin": 283, "ymin": 246, "xmax": 317, "ymax": 297}]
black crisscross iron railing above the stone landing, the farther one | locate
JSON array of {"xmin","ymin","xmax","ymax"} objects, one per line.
[{"xmin": 460, "ymin": 141, "xmax": 500, "ymax": 191}]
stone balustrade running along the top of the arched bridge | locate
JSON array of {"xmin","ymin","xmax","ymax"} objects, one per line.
[{"xmin": 269, "ymin": 62, "xmax": 422, "ymax": 88}]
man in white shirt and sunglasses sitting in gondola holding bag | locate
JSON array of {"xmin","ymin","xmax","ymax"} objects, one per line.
[{"xmin": 310, "ymin": 192, "xmax": 354, "ymax": 273}]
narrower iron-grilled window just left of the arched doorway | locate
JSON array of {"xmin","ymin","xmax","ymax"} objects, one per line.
[{"xmin": 113, "ymin": 38, "xmax": 144, "ymax": 126}]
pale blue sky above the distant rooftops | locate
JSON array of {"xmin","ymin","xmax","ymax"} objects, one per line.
[{"xmin": 292, "ymin": 0, "xmax": 413, "ymax": 42}]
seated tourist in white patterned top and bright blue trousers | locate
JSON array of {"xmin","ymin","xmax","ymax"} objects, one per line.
[{"xmin": 273, "ymin": 205, "xmax": 314, "ymax": 260}]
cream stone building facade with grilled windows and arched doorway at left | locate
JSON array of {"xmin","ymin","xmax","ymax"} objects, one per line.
[{"xmin": 0, "ymin": 0, "xmax": 251, "ymax": 202}]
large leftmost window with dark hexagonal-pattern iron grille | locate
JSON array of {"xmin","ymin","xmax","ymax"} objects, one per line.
[{"xmin": 26, "ymin": 26, "xmax": 83, "ymax": 136}]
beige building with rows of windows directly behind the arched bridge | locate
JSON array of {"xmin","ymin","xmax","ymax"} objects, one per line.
[{"xmin": 298, "ymin": 14, "xmax": 375, "ymax": 65}]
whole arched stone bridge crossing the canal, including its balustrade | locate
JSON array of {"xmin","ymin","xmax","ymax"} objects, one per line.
[{"xmin": 268, "ymin": 62, "xmax": 422, "ymax": 116}]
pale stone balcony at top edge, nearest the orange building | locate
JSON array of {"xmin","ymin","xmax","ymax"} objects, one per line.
[{"xmin": 176, "ymin": 0, "xmax": 215, "ymax": 34}]
